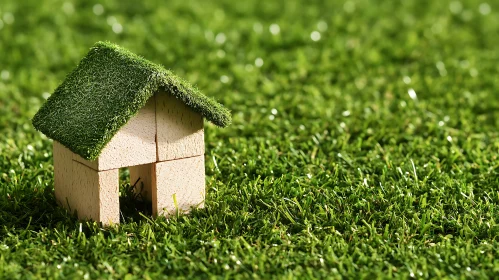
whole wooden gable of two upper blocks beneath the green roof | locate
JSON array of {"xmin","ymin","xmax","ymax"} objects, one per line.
[{"xmin": 73, "ymin": 92, "xmax": 204, "ymax": 171}]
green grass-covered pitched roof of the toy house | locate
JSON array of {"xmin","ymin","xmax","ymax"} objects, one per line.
[{"xmin": 33, "ymin": 42, "xmax": 231, "ymax": 160}]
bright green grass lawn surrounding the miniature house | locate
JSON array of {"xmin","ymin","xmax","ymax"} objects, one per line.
[{"xmin": 0, "ymin": 0, "xmax": 499, "ymax": 279}]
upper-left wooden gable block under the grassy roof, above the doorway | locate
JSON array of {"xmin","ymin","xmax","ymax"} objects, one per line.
[{"xmin": 74, "ymin": 96, "xmax": 156, "ymax": 171}]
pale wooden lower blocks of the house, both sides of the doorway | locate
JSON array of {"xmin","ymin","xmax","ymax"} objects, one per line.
[{"xmin": 54, "ymin": 141, "xmax": 205, "ymax": 225}]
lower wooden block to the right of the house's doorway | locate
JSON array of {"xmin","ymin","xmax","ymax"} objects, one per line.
[{"xmin": 152, "ymin": 155, "xmax": 205, "ymax": 216}]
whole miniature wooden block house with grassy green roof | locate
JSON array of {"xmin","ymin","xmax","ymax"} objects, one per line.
[{"xmin": 33, "ymin": 42, "xmax": 230, "ymax": 224}]
